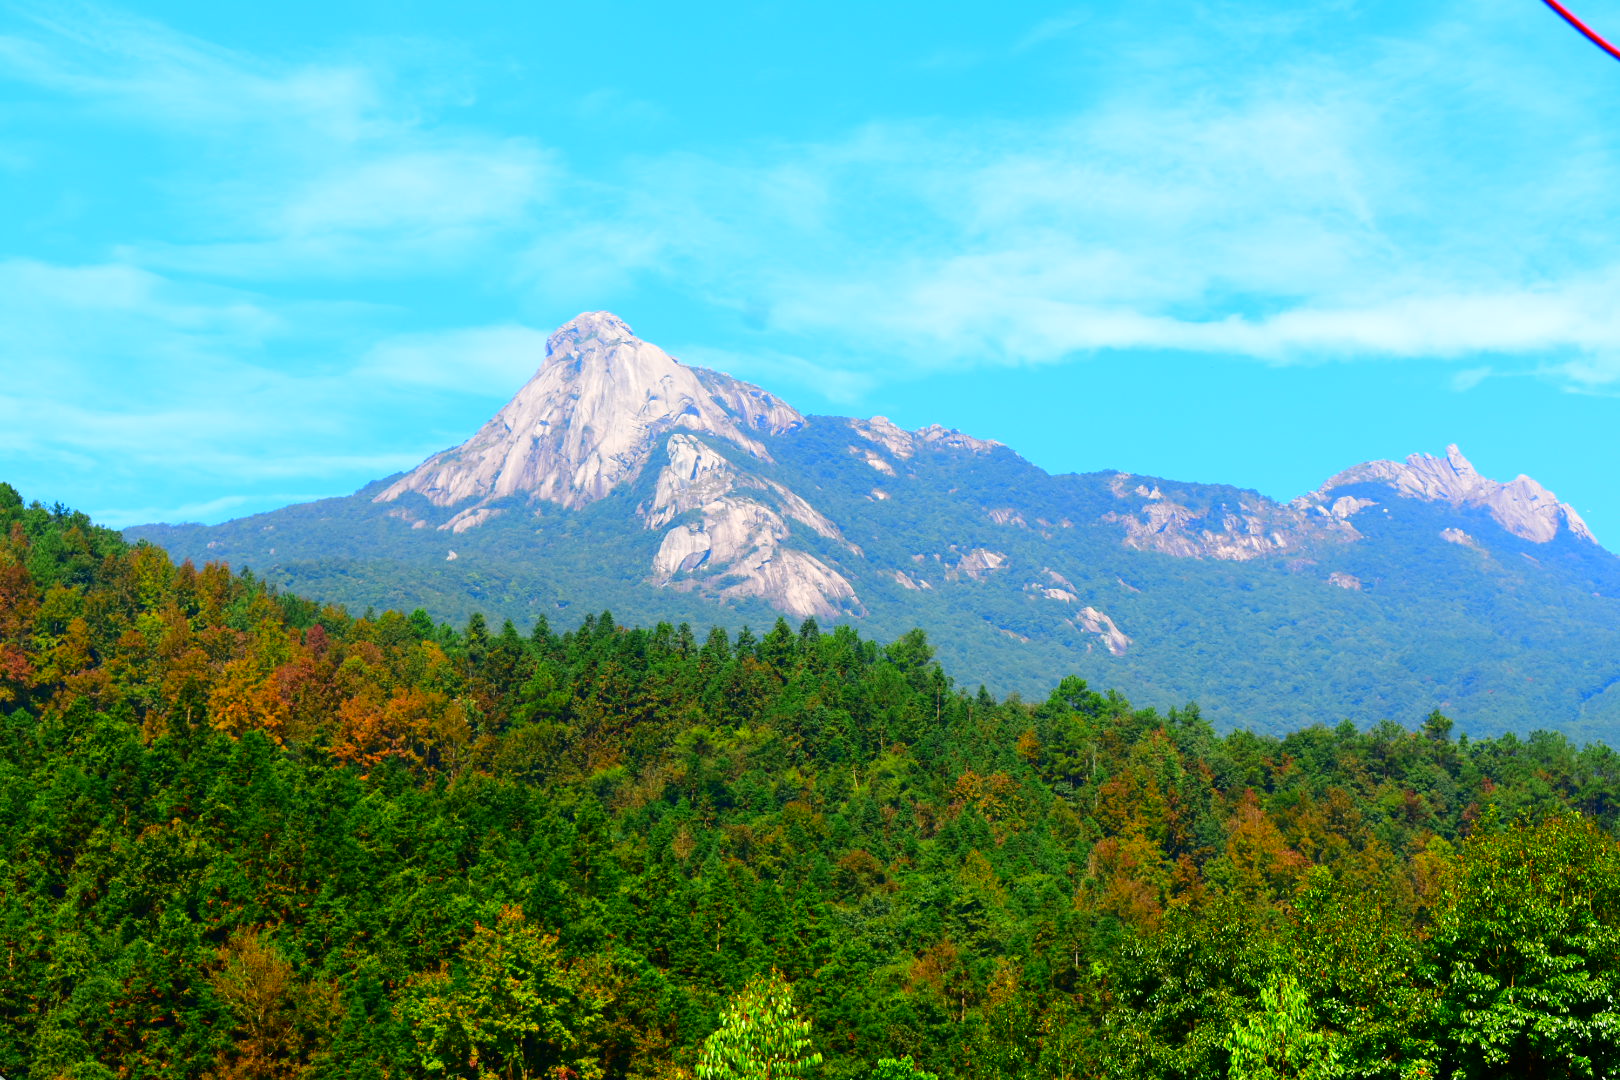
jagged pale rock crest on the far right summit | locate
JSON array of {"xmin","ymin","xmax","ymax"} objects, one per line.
[{"xmin": 1294, "ymin": 444, "xmax": 1597, "ymax": 544}]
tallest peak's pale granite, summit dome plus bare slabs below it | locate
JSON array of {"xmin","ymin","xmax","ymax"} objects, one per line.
[{"xmin": 374, "ymin": 311, "xmax": 861, "ymax": 617}]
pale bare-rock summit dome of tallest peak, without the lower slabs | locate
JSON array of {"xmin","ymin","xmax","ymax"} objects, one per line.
[{"xmin": 376, "ymin": 311, "xmax": 804, "ymax": 507}]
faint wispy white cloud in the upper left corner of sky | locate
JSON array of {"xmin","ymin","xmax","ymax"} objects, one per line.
[{"xmin": 0, "ymin": 5, "xmax": 557, "ymax": 279}]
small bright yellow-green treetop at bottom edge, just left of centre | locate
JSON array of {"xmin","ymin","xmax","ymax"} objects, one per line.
[{"xmin": 697, "ymin": 970, "xmax": 821, "ymax": 1080}]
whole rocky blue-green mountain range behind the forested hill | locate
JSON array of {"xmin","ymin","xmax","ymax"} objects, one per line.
[{"xmin": 130, "ymin": 313, "xmax": 1620, "ymax": 737}]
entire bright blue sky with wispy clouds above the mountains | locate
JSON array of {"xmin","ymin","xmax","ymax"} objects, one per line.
[{"xmin": 0, "ymin": 0, "xmax": 1620, "ymax": 547}]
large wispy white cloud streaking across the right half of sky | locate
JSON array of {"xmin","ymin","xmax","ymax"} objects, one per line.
[{"xmin": 518, "ymin": 11, "xmax": 1620, "ymax": 385}]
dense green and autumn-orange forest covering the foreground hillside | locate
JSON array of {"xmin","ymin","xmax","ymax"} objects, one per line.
[{"xmin": 0, "ymin": 484, "xmax": 1620, "ymax": 1080}]
